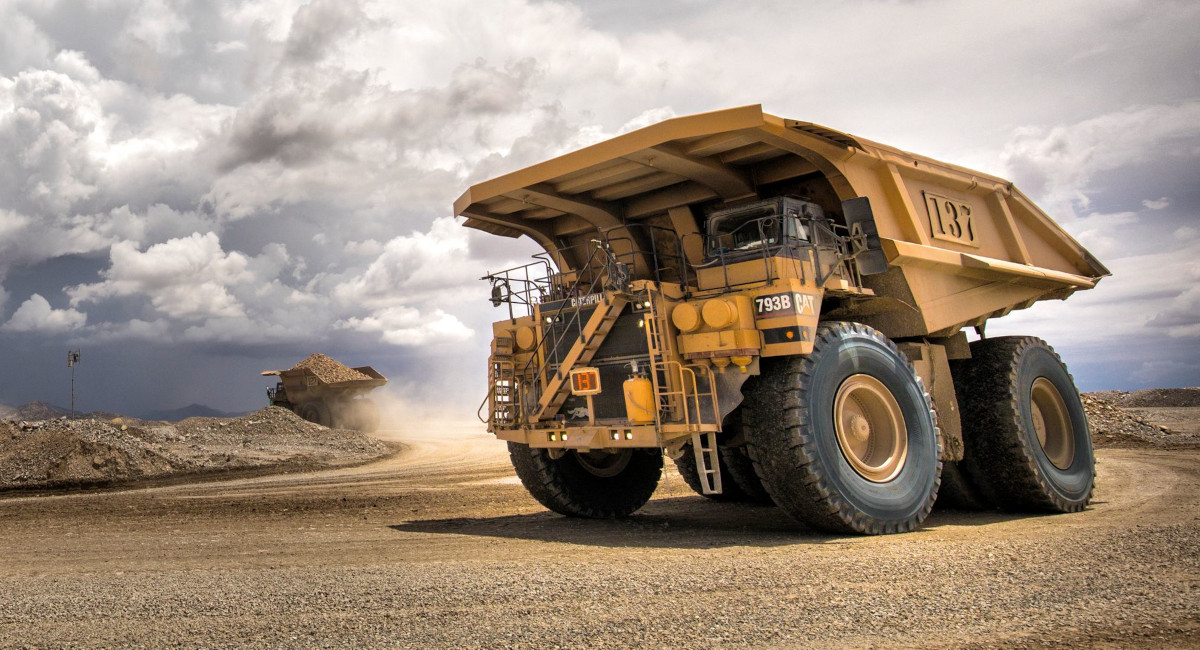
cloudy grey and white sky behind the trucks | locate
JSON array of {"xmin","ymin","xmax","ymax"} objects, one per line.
[{"xmin": 0, "ymin": 0, "xmax": 1200, "ymax": 415}]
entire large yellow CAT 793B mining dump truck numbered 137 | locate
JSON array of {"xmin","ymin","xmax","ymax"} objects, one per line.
[{"xmin": 455, "ymin": 106, "xmax": 1108, "ymax": 534}]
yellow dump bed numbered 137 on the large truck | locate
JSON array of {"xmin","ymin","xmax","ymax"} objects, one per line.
[{"xmin": 455, "ymin": 106, "xmax": 1109, "ymax": 337}]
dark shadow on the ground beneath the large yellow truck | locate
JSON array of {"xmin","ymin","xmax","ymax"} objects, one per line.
[{"xmin": 389, "ymin": 496, "xmax": 1038, "ymax": 549}]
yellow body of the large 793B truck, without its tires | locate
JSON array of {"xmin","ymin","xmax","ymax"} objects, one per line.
[{"xmin": 454, "ymin": 106, "xmax": 1108, "ymax": 534}]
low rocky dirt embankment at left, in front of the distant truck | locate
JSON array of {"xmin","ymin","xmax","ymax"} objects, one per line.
[{"xmin": 0, "ymin": 407, "xmax": 389, "ymax": 489}]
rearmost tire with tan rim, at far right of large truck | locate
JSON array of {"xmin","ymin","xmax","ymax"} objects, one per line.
[{"xmin": 950, "ymin": 336, "xmax": 1096, "ymax": 512}]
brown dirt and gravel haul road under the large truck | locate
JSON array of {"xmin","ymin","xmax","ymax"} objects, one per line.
[{"xmin": 0, "ymin": 428, "xmax": 1200, "ymax": 648}]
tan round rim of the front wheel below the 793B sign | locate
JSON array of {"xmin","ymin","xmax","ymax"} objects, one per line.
[{"xmin": 833, "ymin": 374, "xmax": 908, "ymax": 483}]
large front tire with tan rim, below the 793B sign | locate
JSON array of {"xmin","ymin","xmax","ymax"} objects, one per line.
[{"xmin": 745, "ymin": 323, "xmax": 942, "ymax": 535}]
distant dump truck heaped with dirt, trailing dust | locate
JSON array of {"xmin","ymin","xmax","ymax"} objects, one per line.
[{"xmin": 262, "ymin": 354, "xmax": 388, "ymax": 432}]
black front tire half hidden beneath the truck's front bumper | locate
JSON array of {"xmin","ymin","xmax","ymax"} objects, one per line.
[{"xmin": 509, "ymin": 443, "xmax": 662, "ymax": 519}]
